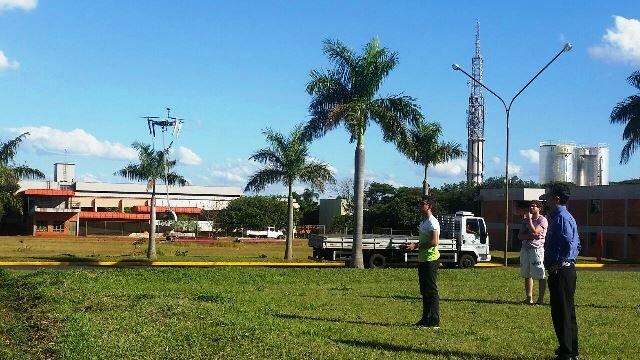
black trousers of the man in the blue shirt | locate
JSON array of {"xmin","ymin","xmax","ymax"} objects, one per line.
[{"xmin": 548, "ymin": 266, "xmax": 578, "ymax": 357}]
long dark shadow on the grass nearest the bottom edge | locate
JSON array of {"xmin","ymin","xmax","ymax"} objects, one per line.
[{"xmin": 332, "ymin": 339, "xmax": 529, "ymax": 360}]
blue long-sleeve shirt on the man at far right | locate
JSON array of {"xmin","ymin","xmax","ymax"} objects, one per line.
[{"xmin": 544, "ymin": 205, "xmax": 580, "ymax": 267}]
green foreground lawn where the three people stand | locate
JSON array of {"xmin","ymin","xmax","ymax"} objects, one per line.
[{"xmin": 0, "ymin": 268, "xmax": 640, "ymax": 360}]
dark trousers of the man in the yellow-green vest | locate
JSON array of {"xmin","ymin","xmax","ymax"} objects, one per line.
[{"xmin": 418, "ymin": 260, "xmax": 440, "ymax": 326}]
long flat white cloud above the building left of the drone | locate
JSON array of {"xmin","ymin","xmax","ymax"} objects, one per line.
[{"xmin": 9, "ymin": 126, "xmax": 138, "ymax": 160}]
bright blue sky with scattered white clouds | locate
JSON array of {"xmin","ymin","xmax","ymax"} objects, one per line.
[{"xmin": 0, "ymin": 0, "xmax": 640, "ymax": 191}]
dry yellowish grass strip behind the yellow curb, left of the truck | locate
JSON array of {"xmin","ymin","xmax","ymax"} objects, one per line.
[{"xmin": 0, "ymin": 236, "xmax": 311, "ymax": 261}]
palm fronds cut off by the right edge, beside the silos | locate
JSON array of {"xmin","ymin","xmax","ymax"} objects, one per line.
[{"xmin": 610, "ymin": 71, "xmax": 640, "ymax": 164}]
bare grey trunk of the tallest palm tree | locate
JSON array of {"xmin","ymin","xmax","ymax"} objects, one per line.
[{"xmin": 350, "ymin": 130, "xmax": 364, "ymax": 269}]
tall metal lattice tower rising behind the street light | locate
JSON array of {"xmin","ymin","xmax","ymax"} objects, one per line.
[{"xmin": 467, "ymin": 21, "xmax": 485, "ymax": 184}]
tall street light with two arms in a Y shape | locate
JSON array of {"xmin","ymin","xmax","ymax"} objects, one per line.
[{"xmin": 451, "ymin": 43, "xmax": 573, "ymax": 266}]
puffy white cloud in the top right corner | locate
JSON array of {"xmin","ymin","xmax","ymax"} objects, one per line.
[{"xmin": 589, "ymin": 16, "xmax": 640, "ymax": 64}]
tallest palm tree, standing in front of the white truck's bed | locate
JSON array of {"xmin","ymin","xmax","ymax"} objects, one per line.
[{"xmin": 305, "ymin": 38, "xmax": 422, "ymax": 268}]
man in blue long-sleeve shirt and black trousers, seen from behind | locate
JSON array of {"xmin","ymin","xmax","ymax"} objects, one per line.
[{"xmin": 540, "ymin": 184, "xmax": 580, "ymax": 360}]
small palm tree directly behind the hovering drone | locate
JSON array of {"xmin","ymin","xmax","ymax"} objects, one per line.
[{"xmin": 114, "ymin": 142, "xmax": 189, "ymax": 260}]
